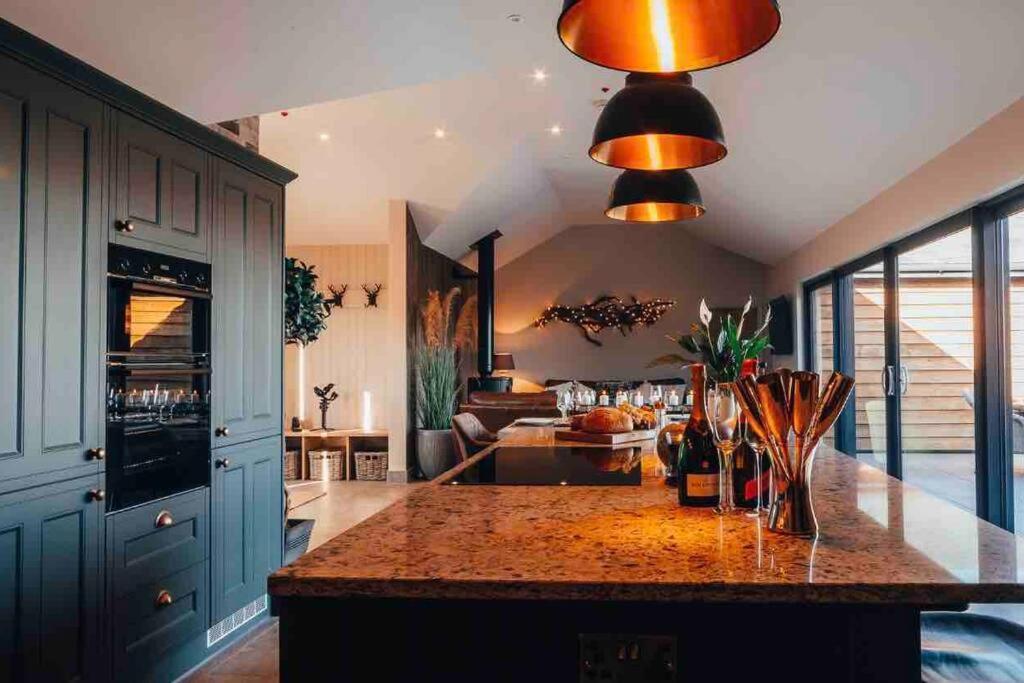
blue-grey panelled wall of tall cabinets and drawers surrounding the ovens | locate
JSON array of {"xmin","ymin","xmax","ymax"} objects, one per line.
[{"xmin": 0, "ymin": 14, "xmax": 295, "ymax": 683}]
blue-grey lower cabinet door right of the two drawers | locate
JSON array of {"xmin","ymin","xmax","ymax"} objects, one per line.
[{"xmin": 211, "ymin": 436, "xmax": 284, "ymax": 624}]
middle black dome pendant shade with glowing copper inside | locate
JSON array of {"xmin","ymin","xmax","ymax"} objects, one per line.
[{"xmin": 590, "ymin": 74, "xmax": 727, "ymax": 171}]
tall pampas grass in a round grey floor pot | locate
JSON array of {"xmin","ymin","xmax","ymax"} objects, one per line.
[{"xmin": 415, "ymin": 287, "xmax": 476, "ymax": 479}]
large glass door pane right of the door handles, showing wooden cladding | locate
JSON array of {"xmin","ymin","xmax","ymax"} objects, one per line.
[{"xmin": 894, "ymin": 228, "xmax": 976, "ymax": 512}]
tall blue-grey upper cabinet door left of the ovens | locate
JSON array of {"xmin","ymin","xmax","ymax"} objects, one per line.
[{"xmin": 0, "ymin": 57, "xmax": 106, "ymax": 492}]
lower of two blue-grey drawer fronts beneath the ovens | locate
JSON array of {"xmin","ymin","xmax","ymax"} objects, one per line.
[{"xmin": 114, "ymin": 562, "xmax": 209, "ymax": 681}]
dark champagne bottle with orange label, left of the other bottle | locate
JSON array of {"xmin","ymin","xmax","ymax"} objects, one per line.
[{"xmin": 678, "ymin": 364, "xmax": 719, "ymax": 507}]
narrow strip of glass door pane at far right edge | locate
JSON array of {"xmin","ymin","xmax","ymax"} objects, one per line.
[{"xmin": 1009, "ymin": 211, "xmax": 1024, "ymax": 533}]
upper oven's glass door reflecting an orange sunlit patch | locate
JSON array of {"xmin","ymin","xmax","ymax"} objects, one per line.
[{"xmin": 106, "ymin": 275, "xmax": 210, "ymax": 362}]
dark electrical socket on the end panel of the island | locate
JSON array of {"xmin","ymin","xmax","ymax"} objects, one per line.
[{"xmin": 580, "ymin": 633, "xmax": 679, "ymax": 683}]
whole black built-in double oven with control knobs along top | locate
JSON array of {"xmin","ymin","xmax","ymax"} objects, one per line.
[{"xmin": 106, "ymin": 245, "xmax": 211, "ymax": 511}]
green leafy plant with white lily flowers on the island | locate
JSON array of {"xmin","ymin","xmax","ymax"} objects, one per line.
[{"xmin": 647, "ymin": 297, "xmax": 771, "ymax": 382}]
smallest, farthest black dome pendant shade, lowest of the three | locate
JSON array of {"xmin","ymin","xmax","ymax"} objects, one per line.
[{"xmin": 604, "ymin": 170, "xmax": 705, "ymax": 223}]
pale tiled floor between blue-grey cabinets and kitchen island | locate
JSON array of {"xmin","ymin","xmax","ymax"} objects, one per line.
[{"xmin": 185, "ymin": 481, "xmax": 418, "ymax": 683}]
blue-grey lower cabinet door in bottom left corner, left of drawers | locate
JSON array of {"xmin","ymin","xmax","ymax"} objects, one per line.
[{"xmin": 0, "ymin": 476, "xmax": 103, "ymax": 681}]
